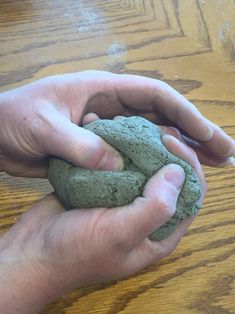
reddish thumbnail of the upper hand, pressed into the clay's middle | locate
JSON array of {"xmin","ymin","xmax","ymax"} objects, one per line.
[{"xmin": 98, "ymin": 150, "xmax": 124, "ymax": 170}]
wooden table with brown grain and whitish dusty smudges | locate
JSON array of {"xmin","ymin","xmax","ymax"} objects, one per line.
[{"xmin": 0, "ymin": 0, "xmax": 235, "ymax": 314}]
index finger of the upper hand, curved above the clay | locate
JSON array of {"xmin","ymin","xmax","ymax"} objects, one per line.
[{"xmin": 109, "ymin": 75, "xmax": 214, "ymax": 141}]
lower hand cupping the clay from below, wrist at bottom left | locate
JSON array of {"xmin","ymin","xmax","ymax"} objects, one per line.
[{"xmin": 0, "ymin": 129, "xmax": 206, "ymax": 314}]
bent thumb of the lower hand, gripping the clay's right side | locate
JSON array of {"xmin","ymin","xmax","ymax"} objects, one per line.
[{"xmin": 110, "ymin": 164, "xmax": 185, "ymax": 249}]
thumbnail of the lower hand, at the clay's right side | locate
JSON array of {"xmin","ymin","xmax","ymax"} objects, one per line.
[{"xmin": 164, "ymin": 164, "xmax": 185, "ymax": 190}]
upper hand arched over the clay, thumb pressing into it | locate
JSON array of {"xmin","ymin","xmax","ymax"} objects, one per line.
[{"xmin": 0, "ymin": 71, "xmax": 235, "ymax": 177}]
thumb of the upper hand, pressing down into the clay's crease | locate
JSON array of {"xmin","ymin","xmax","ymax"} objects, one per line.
[{"xmin": 43, "ymin": 119, "xmax": 123, "ymax": 170}]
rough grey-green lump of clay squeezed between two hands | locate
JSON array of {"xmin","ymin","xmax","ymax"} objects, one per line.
[{"xmin": 49, "ymin": 117, "xmax": 201, "ymax": 240}]
